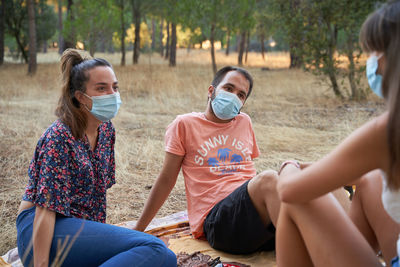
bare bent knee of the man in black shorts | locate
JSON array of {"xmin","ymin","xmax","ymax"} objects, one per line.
[{"xmin": 247, "ymin": 170, "xmax": 280, "ymax": 225}]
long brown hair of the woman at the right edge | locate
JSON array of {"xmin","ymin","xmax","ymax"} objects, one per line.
[{"xmin": 360, "ymin": 0, "xmax": 400, "ymax": 190}]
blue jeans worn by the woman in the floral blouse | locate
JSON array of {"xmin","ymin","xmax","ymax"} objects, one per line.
[{"xmin": 17, "ymin": 207, "xmax": 177, "ymax": 266}]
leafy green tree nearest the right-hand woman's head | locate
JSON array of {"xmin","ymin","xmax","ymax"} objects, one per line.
[{"xmin": 273, "ymin": 0, "xmax": 384, "ymax": 99}]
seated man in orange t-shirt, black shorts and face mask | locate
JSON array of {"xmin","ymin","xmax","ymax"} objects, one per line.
[{"xmin": 136, "ymin": 66, "xmax": 279, "ymax": 254}]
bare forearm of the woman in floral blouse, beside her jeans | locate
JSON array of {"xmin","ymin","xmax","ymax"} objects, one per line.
[{"xmin": 32, "ymin": 206, "xmax": 56, "ymax": 267}]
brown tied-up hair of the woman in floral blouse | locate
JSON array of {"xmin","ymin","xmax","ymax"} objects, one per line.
[{"xmin": 55, "ymin": 49, "xmax": 112, "ymax": 139}]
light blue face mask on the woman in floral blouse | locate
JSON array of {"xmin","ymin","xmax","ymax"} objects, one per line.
[{"xmin": 84, "ymin": 92, "xmax": 122, "ymax": 121}]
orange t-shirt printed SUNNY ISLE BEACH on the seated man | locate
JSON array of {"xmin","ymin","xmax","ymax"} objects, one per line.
[{"xmin": 165, "ymin": 112, "xmax": 260, "ymax": 238}]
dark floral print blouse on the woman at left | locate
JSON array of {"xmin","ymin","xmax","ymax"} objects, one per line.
[{"xmin": 23, "ymin": 120, "xmax": 115, "ymax": 222}]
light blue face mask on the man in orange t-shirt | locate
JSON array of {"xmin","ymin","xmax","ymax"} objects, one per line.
[{"xmin": 211, "ymin": 90, "xmax": 243, "ymax": 120}]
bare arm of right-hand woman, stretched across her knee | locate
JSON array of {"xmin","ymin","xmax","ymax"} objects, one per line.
[{"xmin": 278, "ymin": 113, "xmax": 389, "ymax": 202}]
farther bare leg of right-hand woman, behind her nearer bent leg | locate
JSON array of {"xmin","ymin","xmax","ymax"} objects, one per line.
[{"xmin": 349, "ymin": 171, "xmax": 400, "ymax": 266}]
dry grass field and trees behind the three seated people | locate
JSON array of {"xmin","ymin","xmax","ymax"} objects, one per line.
[{"xmin": 0, "ymin": 0, "xmax": 384, "ymax": 255}]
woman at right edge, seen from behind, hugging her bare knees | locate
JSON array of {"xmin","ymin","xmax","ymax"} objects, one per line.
[{"xmin": 276, "ymin": 0, "xmax": 400, "ymax": 267}]
